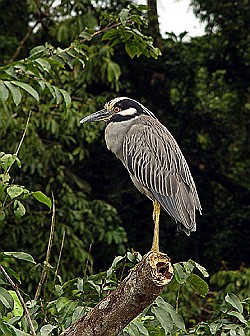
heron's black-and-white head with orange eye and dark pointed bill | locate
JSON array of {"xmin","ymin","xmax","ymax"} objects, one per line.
[{"xmin": 80, "ymin": 97, "xmax": 155, "ymax": 123}]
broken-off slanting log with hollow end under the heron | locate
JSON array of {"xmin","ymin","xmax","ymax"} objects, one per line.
[{"xmin": 60, "ymin": 252, "xmax": 173, "ymax": 336}]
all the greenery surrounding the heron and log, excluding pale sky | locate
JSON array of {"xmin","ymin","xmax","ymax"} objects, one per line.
[{"xmin": 0, "ymin": 0, "xmax": 250, "ymax": 336}]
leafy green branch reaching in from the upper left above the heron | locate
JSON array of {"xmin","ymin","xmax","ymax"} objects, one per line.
[{"xmin": 0, "ymin": 5, "xmax": 160, "ymax": 107}]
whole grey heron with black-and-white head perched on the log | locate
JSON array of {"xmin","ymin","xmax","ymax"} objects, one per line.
[{"xmin": 80, "ymin": 97, "xmax": 202, "ymax": 253}]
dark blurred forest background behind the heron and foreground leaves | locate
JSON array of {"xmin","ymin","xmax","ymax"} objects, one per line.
[{"xmin": 0, "ymin": 0, "xmax": 250, "ymax": 279}]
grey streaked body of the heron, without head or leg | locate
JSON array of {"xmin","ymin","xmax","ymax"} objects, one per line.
[{"xmin": 105, "ymin": 115, "xmax": 201, "ymax": 235}]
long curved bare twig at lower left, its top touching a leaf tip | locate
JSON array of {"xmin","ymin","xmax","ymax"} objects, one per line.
[{"xmin": 34, "ymin": 193, "xmax": 56, "ymax": 301}]
